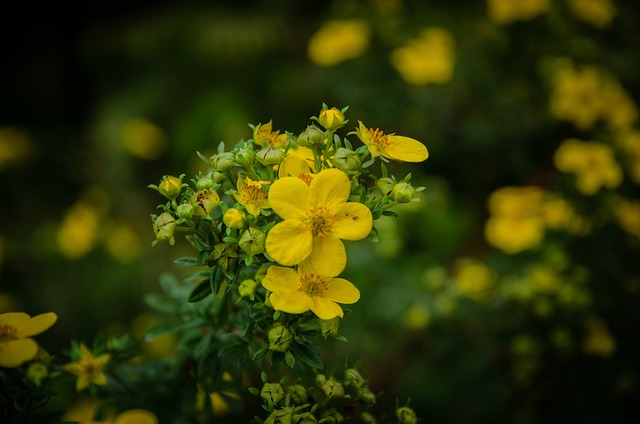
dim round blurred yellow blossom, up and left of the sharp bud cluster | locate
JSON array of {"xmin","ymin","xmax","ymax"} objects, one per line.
[{"xmin": 121, "ymin": 118, "xmax": 168, "ymax": 160}]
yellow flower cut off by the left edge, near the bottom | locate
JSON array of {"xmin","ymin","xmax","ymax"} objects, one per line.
[{"xmin": 0, "ymin": 312, "xmax": 58, "ymax": 368}]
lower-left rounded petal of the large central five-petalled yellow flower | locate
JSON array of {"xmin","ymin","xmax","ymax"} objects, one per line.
[{"xmin": 265, "ymin": 220, "xmax": 313, "ymax": 266}]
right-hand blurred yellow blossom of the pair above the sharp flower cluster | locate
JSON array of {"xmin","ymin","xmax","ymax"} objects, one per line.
[{"xmin": 391, "ymin": 27, "xmax": 455, "ymax": 85}]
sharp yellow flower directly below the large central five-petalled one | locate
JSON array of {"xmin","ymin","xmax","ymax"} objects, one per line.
[{"xmin": 262, "ymin": 261, "xmax": 360, "ymax": 320}]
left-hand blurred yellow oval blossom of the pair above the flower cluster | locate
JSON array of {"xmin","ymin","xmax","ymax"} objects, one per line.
[{"xmin": 307, "ymin": 19, "xmax": 371, "ymax": 66}]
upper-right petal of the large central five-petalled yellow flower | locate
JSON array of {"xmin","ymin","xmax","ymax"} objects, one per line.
[{"xmin": 309, "ymin": 168, "xmax": 351, "ymax": 211}]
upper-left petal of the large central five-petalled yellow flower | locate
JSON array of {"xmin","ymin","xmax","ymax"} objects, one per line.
[{"xmin": 269, "ymin": 177, "xmax": 311, "ymax": 219}]
